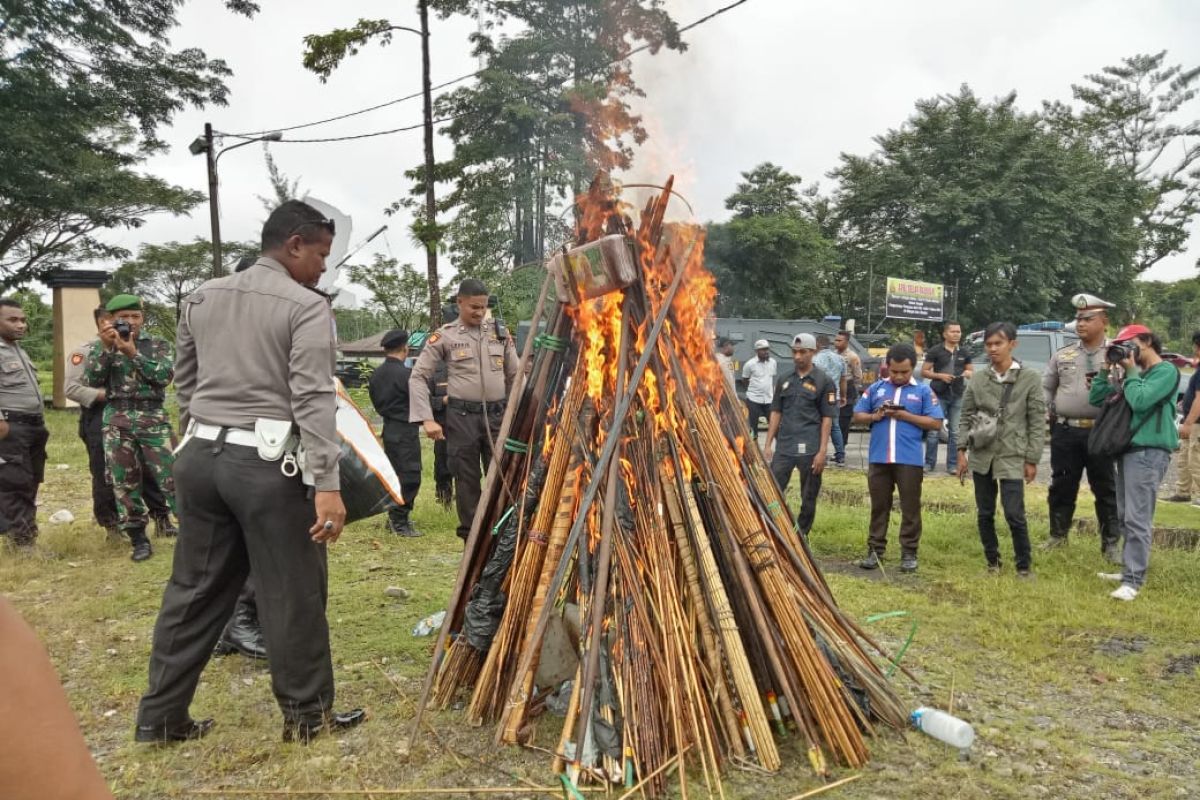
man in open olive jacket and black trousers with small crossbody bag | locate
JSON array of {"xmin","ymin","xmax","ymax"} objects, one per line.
[{"xmin": 958, "ymin": 323, "xmax": 1046, "ymax": 578}]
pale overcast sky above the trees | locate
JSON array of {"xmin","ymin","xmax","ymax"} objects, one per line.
[{"xmin": 103, "ymin": 0, "xmax": 1200, "ymax": 299}]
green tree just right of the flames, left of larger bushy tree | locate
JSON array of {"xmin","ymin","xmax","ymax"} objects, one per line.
[{"xmin": 704, "ymin": 163, "xmax": 845, "ymax": 319}]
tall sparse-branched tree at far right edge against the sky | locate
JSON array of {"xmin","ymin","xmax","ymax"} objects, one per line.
[{"xmin": 1044, "ymin": 50, "xmax": 1200, "ymax": 272}]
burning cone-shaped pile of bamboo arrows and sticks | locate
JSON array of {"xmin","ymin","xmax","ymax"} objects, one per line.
[{"xmin": 414, "ymin": 179, "xmax": 905, "ymax": 796}]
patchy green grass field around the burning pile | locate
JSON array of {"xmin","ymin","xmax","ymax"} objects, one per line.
[{"xmin": 0, "ymin": 413, "xmax": 1200, "ymax": 800}]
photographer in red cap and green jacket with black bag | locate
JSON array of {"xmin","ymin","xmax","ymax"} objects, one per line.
[{"xmin": 1088, "ymin": 325, "xmax": 1180, "ymax": 601}]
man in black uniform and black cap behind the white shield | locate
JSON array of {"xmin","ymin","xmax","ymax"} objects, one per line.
[{"xmin": 368, "ymin": 330, "xmax": 421, "ymax": 536}]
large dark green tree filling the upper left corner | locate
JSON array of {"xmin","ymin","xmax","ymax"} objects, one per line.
[{"xmin": 0, "ymin": 0, "xmax": 257, "ymax": 287}]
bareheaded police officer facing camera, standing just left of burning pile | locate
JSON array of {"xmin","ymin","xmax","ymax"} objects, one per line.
[{"xmin": 408, "ymin": 279, "xmax": 517, "ymax": 540}]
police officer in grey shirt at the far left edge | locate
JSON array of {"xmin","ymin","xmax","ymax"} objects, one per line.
[{"xmin": 0, "ymin": 297, "xmax": 50, "ymax": 547}]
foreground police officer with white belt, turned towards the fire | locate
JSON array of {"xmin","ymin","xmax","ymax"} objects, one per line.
[{"xmin": 134, "ymin": 200, "xmax": 366, "ymax": 742}]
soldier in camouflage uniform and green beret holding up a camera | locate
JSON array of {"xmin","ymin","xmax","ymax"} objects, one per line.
[{"xmin": 83, "ymin": 295, "xmax": 175, "ymax": 561}]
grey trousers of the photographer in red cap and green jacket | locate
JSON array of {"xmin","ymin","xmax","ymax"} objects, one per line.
[{"xmin": 1117, "ymin": 447, "xmax": 1171, "ymax": 589}]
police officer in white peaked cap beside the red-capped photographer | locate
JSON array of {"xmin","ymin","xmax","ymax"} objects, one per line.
[{"xmin": 1042, "ymin": 294, "xmax": 1122, "ymax": 564}]
